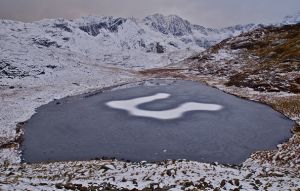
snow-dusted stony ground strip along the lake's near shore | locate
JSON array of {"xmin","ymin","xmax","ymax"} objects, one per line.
[{"xmin": 0, "ymin": 160, "xmax": 299, "ymax": 190}]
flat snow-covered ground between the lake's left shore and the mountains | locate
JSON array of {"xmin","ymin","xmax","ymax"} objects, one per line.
[{"xmin": 0, "ymin": 61, "xmax": 136, "ymax": 163}]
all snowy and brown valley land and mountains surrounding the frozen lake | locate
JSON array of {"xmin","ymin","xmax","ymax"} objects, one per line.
[{"xmin": 0, "ymin": 14, "xmax": 300, "ymax": 190}]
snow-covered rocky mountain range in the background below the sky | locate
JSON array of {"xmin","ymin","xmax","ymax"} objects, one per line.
[{"xmin": 0, "ymin": 14, "xmax": 256, "ymax": 78}]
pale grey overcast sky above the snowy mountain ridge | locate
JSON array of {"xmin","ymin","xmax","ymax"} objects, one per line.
[{"xmin": 0, "ymin": 0, "xmax": 300, "ymax": 27}]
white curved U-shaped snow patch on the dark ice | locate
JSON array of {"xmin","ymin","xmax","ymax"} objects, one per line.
[{"xmin": 106, "ymin": 93, "xmax": 222, "ymax": 119}]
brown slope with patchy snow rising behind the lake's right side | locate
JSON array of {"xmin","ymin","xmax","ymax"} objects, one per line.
[{"xmin": 189, "ymin": 24, "xmax": 300, "ymax": 93}]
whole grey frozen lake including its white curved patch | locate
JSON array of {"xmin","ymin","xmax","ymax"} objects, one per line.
[{"xmin": 22, "ymin": 80, "xmax": 294, "ymax": 164}]
